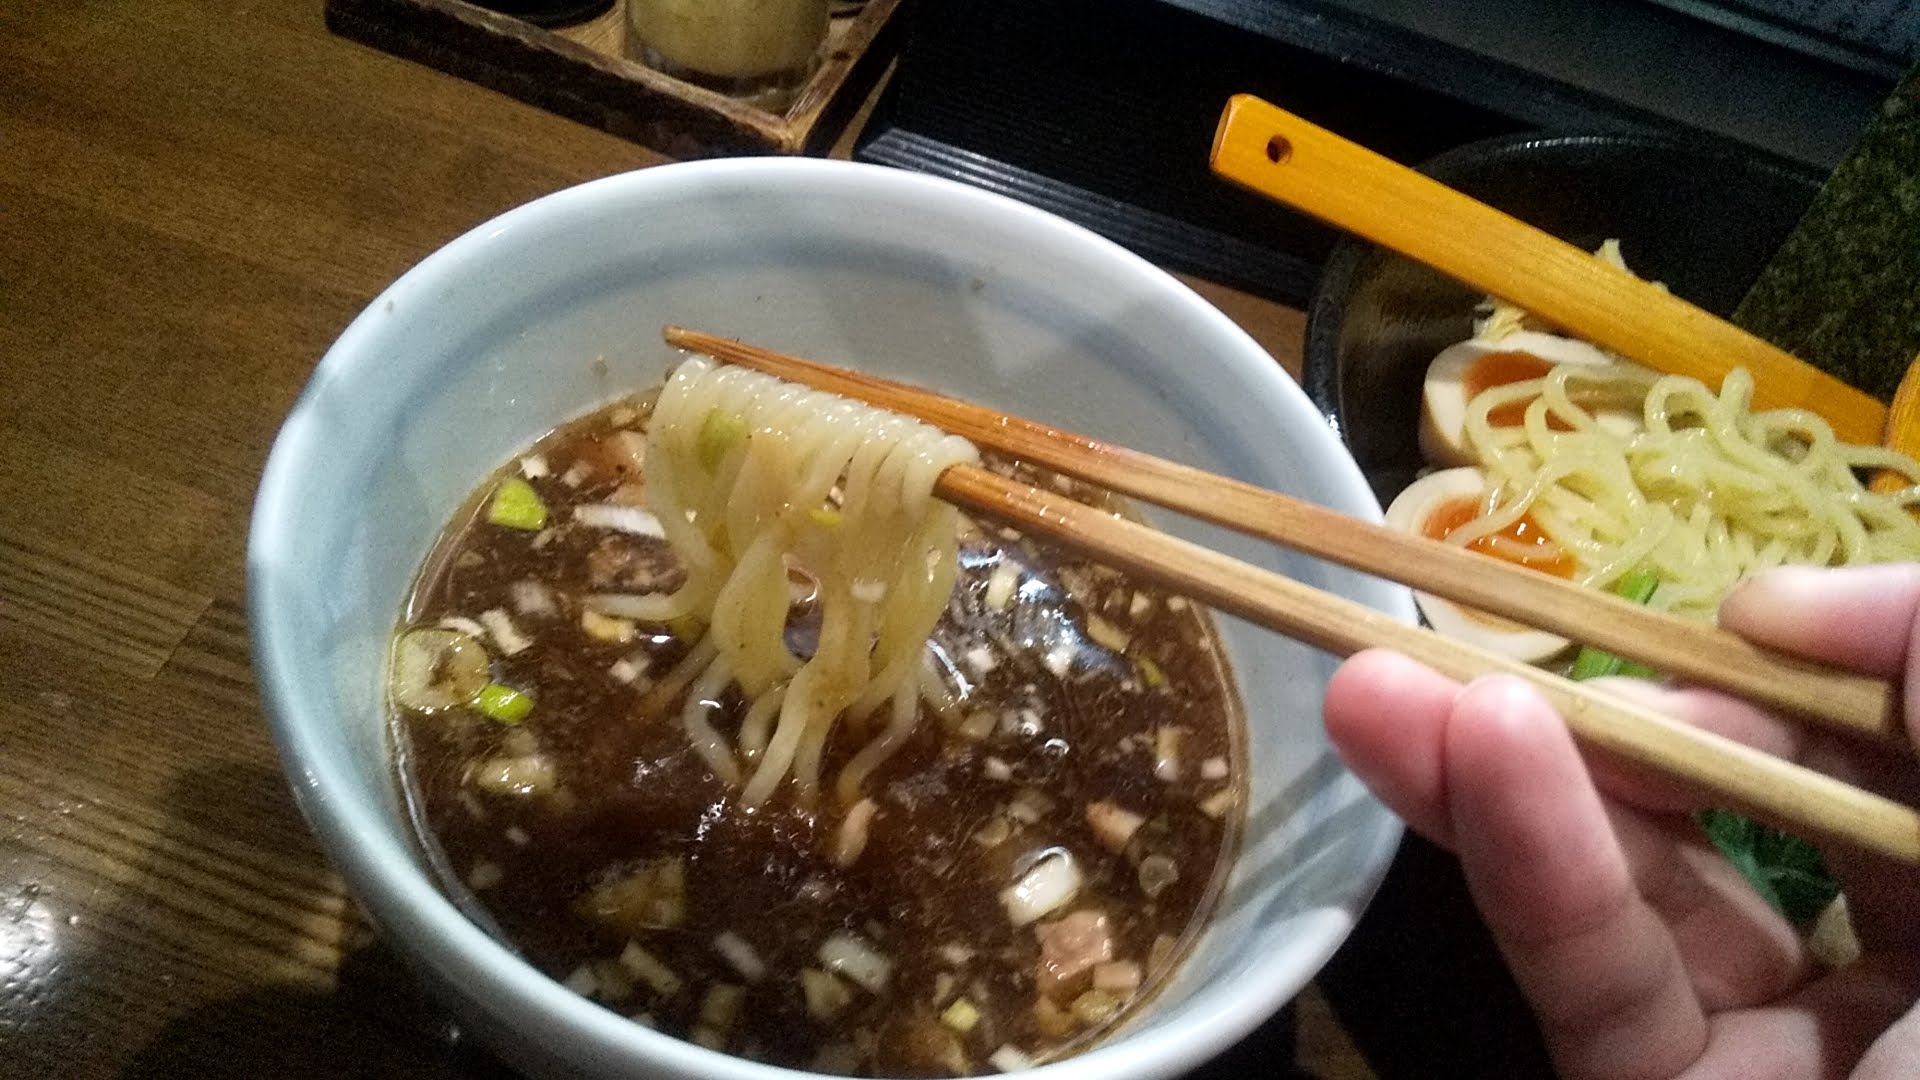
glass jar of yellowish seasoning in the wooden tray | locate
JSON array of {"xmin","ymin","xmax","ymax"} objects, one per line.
[{"xmin": 626, "ymin": 0, "xmax": 829, "ymax": 108}]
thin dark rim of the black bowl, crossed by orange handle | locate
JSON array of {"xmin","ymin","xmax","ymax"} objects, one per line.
[{"xmin": 1300, "ymin": 131, "xmax": 1822, "ymax": 444}]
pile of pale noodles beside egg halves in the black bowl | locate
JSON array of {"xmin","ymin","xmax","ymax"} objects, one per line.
[{"xmin": 1448, "ymin": 365, "xmax": 1920, "ymax": 619}]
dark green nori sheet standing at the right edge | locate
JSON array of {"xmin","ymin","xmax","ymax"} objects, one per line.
[{"xmin": 1734, "ymin": 67, "xmax": 1920, "ymax": 400}]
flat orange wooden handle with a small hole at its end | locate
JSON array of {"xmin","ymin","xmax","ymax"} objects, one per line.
[{"xmin": 1212, "ymin": 94, "xmax": 1887, "ymax": 446}]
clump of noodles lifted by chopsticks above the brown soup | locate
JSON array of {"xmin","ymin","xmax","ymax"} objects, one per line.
[{"xmin": 647, "ymin": 357, "xmax": 979, "ymax": 807}]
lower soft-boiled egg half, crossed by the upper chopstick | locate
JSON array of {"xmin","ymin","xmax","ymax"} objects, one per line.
[{"xmin": 1386, "ymin": 467, "xmax": 1574, "ymax": 663}]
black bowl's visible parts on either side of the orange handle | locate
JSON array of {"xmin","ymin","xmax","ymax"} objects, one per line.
[{"xmin": 1302, "ymin": 135, "xmax": 1820, "ymax": 502}]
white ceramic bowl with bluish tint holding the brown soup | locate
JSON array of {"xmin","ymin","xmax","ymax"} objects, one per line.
[{"xmin": 248, "ymin": 160, "xmax": 1413, "ymax": 1080}]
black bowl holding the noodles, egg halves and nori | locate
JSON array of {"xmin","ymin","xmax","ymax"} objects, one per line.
[{"xmin": 1302, "ymin": 135, "xmax": 1820, "ymax": 1080}]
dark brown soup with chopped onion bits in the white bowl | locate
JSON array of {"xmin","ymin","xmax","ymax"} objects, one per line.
[{"xmin": 394, "ymin": 390, "xmax": 1244, "ymax": 1076}]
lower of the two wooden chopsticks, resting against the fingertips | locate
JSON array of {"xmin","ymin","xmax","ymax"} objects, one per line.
[{"xmin": 666, "ymin": 329, "xmax": 1920, "ymax": 865}]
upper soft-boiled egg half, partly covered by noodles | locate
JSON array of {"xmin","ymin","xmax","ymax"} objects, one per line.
[{"xmin": 1421, "ymin": 331, "xmax": 1638, "ymax": 465}]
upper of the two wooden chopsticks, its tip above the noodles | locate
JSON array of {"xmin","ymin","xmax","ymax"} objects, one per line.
[{"xmin": 664, "ymin": 327, "xmax": 1907, "ymax": 746}]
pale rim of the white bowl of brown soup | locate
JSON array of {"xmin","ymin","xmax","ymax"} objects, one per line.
[{"xmin": 246, "ymin": 158, "xmax": 1413, "ymax": 1080}]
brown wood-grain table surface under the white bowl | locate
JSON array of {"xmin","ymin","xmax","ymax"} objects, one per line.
[{"xmin": 0, "ymin": 0, "xmax": 1302, "ymax": 1078}]
